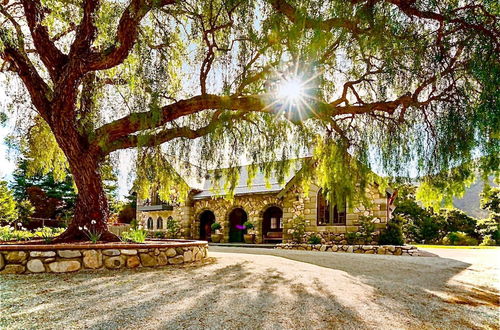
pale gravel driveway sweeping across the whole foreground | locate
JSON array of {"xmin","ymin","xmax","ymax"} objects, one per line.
[{"xmin": 0, "ymin": 247, "xmax": 500, "ymax": 329}]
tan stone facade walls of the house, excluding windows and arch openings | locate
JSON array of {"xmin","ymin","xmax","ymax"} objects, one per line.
[{"xmin": 139, "ymin": 180, "xmax": 387, "ymax": 243}]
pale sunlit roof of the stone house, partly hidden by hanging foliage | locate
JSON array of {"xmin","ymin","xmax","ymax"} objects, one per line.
[{"xmin": 193, "ymin": 163, "xmax": 300, "ymax": 199}]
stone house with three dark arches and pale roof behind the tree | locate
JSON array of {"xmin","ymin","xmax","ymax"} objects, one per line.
[{"xmin": 137, "ymin": 162, "xmax": 394, "ymax": 243}]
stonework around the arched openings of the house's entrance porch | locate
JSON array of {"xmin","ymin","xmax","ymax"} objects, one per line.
[{"xmin": 191, "ymin": 193, "xmax": 283, "ymax": 243}]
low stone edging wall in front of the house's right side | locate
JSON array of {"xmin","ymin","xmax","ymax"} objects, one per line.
[{"xmin": 275, "ymin": 243, "xmax": 419, "ymax": 256}]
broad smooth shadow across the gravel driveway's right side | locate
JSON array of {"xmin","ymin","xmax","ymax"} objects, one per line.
[{"xmin": 211, "ymin": 249, "xmax": 500, "ymax": 328}]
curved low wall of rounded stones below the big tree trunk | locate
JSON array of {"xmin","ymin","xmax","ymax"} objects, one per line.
[{"xmin": 0, "ymin": 243, "xmax": 208, "ymax": 274}]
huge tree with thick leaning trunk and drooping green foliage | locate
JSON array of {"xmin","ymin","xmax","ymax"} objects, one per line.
[{"xmin": 0, "ymin": 0, "xmax": 500, "ymax": 240}]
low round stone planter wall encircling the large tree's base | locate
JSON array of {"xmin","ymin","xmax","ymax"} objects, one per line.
[{"xmin": 0, "ymin": 240, "xmax": 208, "ymax": 274}]
